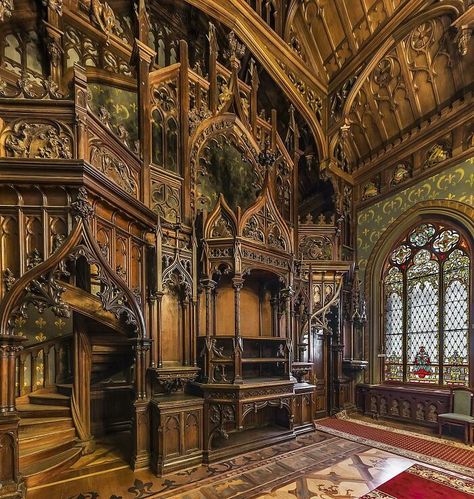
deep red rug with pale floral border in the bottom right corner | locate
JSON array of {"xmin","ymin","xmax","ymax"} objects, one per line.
[{"xmin": 361, "ymin": 464, "xmax": 474, "ymax": 499}]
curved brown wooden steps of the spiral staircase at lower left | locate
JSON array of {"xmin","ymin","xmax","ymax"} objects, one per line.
[{"xmin": 17, "ymin": 385, "xmax": 82, "ymax": 487}]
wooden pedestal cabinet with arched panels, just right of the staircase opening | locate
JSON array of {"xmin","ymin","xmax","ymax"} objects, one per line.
[{"xmin": 151, "ymin": 393, "xmax": 204, "ymax": 475}]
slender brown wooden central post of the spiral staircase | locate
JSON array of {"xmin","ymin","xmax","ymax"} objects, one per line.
[{"xmin": 71, "ymin": 314, "xmax": 95, "ymax": 454}]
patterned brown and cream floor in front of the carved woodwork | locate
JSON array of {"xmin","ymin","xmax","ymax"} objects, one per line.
[{"xmin": 27, "ymin": 432, "xmax": 413, "ymax": 499}]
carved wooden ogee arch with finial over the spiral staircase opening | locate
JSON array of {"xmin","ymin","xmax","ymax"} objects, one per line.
[{"xmin": 0, "ymin": 188, "xmax": 146, "ymax": 338}]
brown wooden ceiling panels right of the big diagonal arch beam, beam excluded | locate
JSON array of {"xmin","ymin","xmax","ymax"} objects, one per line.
[{"xmin": 284, "ymin": 0, "xmax": 474, "ymax": 171}]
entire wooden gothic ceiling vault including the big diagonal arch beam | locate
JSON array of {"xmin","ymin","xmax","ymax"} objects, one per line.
[{"xmin": 186, "ymin": 0, "xmax": 474, "ymax": 183}]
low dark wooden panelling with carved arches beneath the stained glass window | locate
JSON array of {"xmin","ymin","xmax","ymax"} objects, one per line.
[{"xmin": 356, "ymin": 384, "xmax": 450, "ymax": 427}]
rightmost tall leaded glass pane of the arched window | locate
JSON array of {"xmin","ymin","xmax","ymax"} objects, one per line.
[{"xmin": 443, "ymin": 250, "xmax": 469, "ymax": 385}]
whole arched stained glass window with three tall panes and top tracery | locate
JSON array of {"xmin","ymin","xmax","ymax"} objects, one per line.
[{"xmin": 383, "ymin": 223, "xmax": 471, "ymax": 385}]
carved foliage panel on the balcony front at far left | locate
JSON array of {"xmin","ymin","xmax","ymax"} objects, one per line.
[{"xmin": 3, "ymin": 121, "xmax": 72, "ymax": 159}]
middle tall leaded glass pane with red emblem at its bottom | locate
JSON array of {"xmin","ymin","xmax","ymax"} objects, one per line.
[{"xmin": 407, "ymin": 256, "xmax": 439, "ymax": 383}]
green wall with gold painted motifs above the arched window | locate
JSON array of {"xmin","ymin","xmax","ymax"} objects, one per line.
[{"xmin": 357, "ymin": 157, "xmax": 474, "ymax": 275}]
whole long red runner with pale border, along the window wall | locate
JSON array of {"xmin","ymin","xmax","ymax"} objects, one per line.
[{"xmin": 316, "ymin": 417, "xmax": 474, "ymax": 476}]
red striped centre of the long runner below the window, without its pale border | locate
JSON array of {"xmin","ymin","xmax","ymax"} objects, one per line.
[{"xmin": 317, "ymin": 418, "xmax": 474, "ymax": 469}]
